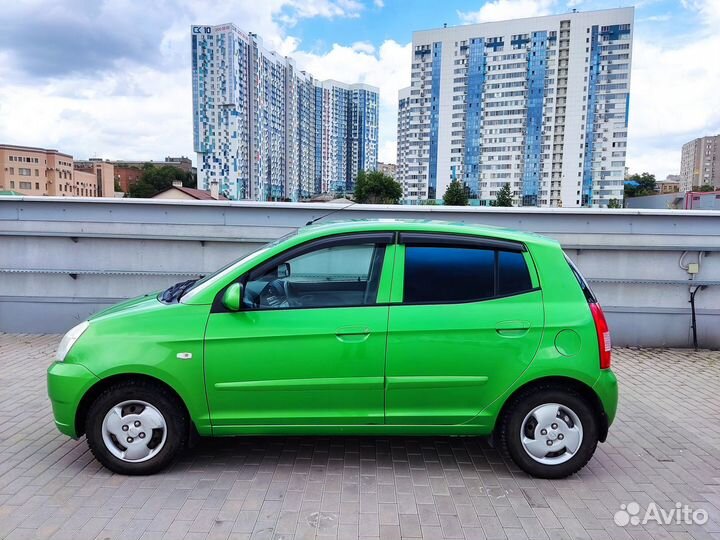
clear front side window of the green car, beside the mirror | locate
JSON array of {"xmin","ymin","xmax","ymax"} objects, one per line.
[{"xmin": 243, "ymin": 242, "xmax": 385, "ymax": 310}]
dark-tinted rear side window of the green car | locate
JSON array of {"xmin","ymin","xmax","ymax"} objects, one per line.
[{"xmin": 403, "ymin": 245, "xmax": 533, "ymax": 304}]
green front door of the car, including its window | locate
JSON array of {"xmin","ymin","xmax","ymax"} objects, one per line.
[{"xmin": 205, "ymin": 233, "xmax": 394, "ymax": 434}]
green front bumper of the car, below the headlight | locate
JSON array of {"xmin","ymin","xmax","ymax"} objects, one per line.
[{"xmin": 47, "ymin": 362, "xmax": 100, "ymax": 438}]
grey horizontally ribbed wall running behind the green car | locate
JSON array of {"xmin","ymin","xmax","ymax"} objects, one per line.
[{"xmin": 0, "ymin": 197, "xmax": 720, "ymax": 348}]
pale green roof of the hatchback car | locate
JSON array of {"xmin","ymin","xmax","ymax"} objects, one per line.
[{"xmin": 298, "ymin": 219, "xmax": 558, "ymax": 245}]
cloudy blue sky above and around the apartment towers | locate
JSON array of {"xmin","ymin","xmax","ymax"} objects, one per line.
[{"xmin": 0, "ymin": 0, "xmax": 720, "ymax": 182}]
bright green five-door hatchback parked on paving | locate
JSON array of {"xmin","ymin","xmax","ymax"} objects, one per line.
[{"xmin": 48, "ymin": 220, "xmax": 617, "ymax": 478}]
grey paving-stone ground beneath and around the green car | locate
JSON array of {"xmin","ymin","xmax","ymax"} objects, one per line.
[{"xmin": 0, "ymin": 334, "xmax": 720, "ymax": 540}]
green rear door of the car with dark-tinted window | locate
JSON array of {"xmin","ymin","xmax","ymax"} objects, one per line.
[{"xmin": 386, "ymin": 233, "xmax": 544, "ymax": 425}]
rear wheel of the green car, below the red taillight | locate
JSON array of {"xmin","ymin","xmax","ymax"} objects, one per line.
[{"xmin": 499, "ymin": 386, "xmax": 598, "ymax": 479}]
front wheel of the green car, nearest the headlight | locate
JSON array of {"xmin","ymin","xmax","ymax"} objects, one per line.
[{"xmin": 85, "ymin": 380, "xmax": 189, "ymax": 475}]
